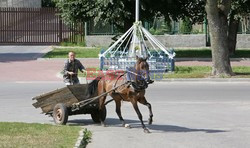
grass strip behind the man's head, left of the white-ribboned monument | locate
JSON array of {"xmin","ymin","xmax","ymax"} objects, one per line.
[{"xmin": 44, "ymin": 47, "xmax": 101, "ymax": 58}]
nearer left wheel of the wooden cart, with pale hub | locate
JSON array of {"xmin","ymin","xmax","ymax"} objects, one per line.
[{"xmin": 53, "ymin": 103, "xmax": 68, "ymax": 125}]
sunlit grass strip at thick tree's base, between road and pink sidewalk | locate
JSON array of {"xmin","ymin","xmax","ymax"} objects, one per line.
[{"xmin": 163, "ymin": 66, "xmax": 250, "ymax": 78}]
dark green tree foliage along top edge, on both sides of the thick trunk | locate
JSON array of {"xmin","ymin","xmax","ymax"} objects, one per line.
[{"xmin": 53, "ymin": 0, "xmax": 250, "ymax": 30}]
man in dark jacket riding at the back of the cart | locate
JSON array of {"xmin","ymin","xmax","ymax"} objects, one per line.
[{"xmin": 63, "ymin": 51, "xmax": 85, "ymax": 85}]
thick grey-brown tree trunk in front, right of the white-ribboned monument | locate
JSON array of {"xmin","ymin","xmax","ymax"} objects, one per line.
[{"xmin": 206, "ymin": 0, "xmax": 233, "ymax": 76}]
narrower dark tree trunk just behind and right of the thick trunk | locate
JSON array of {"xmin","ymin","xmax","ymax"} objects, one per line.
[{"xmin": 228, "ymin": 16, "xmax": 240, "ymax": 55}]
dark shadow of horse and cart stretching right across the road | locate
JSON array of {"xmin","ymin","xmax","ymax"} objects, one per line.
[{"xmin": 68, "ymin": 118, "xmax": 229, "ymax": 133}]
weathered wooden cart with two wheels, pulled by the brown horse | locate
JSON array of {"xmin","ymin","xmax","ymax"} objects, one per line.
[{"xmin": 33, "ymin": 84, "xmax": 107, "ymax": 124}]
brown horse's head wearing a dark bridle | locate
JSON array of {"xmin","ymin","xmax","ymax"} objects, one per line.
[{"xmin": 135, "ymin": 56, "xmax": 150, "ymax": 81}]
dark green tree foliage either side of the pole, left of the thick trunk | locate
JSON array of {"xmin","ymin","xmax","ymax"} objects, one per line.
[{"xmin": 54, "ymin": 0, "xmax": 203, "ymax": 32}]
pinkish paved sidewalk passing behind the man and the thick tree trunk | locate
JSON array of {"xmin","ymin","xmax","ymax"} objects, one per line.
[{"xmin": 0, "ymin": 59, "xmax": 250, "ymax": 81}]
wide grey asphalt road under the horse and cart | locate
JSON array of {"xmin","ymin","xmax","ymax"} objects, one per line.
[{"xmin": 0, "ymin": 82, "xmax": 250, "ymax": 148}]
